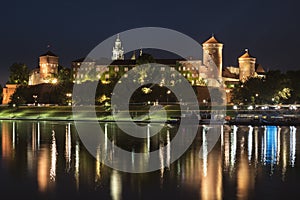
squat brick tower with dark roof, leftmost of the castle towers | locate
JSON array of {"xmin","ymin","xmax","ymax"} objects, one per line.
[{"xmin": 39, "ymin": 51, "xmax": 58, "ymax": 79}]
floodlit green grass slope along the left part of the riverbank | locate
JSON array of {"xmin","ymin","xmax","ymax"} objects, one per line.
[{"xmin": 0, "ymin": 106, "xmax": 180, "ymax": 123}]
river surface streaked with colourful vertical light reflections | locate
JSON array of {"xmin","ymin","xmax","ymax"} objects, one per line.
[{"xmin": 0, "ymin": 121, "xmax": 300, "ymax": 200}]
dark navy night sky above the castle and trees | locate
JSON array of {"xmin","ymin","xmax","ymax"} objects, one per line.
[{"xmin": 0, "ymin": 0, "xmax": 300, "ymax": 85}]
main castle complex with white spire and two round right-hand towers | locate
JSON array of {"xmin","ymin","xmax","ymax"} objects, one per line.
[{"xmin": 72, "ymin": 34, "xmax": 265, "ymax": 86}]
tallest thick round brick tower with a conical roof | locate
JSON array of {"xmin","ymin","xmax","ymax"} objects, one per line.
[{"xmin": 202, "ymin": 36, "xmax": 223, "ymax": 77}]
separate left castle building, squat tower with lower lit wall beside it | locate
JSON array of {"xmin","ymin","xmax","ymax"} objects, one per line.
[{"xmin": 28, "ymin": 51, "xmax": 59, "ymax": 85}]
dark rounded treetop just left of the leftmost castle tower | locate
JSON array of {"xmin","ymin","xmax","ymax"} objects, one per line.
[{"xmin": 8, "ymin": 63, "xmax": 29, "ymax": 85}]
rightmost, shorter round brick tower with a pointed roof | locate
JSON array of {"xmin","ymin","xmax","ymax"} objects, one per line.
[{"xmin": 238, "ymin": 49, "xmax": 256, "ymax": 83}]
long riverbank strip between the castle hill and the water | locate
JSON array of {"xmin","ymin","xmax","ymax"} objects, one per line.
[{"xmin": 0, "ymin": 105, "xmax": 300, "ymax": 126}]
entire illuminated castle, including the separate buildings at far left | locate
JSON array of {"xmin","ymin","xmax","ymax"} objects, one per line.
[{"xmin": 3, "ymin": 34, "xmax": 265, "ymax": 104}]
